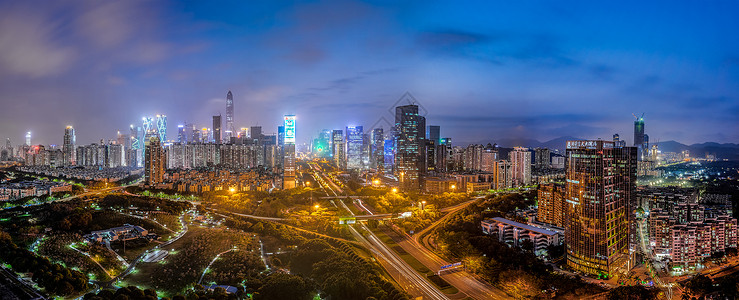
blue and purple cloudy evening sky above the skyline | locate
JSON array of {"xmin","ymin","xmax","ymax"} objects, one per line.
[{"xmin": 0, "ymin": 1, "xmax": 739, "ymax": 145}]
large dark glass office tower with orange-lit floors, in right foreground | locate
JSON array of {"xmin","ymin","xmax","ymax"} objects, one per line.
[{"xmin": 564, "ymin": 140, "xmax": 636, "ymax": 277}]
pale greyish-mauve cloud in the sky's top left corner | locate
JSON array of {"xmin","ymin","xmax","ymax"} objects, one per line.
[{"xmin": 0, "ymin": 6, "xmax": 76, "ymax": 78}]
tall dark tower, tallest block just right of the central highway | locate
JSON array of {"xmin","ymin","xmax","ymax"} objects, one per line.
[{"xmin": 395, "ymin": 104, "xmax": 425, "ymax": 190}]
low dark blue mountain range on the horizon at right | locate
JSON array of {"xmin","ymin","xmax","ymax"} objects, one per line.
[{"xmin": 468, "ymin": 136, "xmax": 739, "ymax": 160}]
